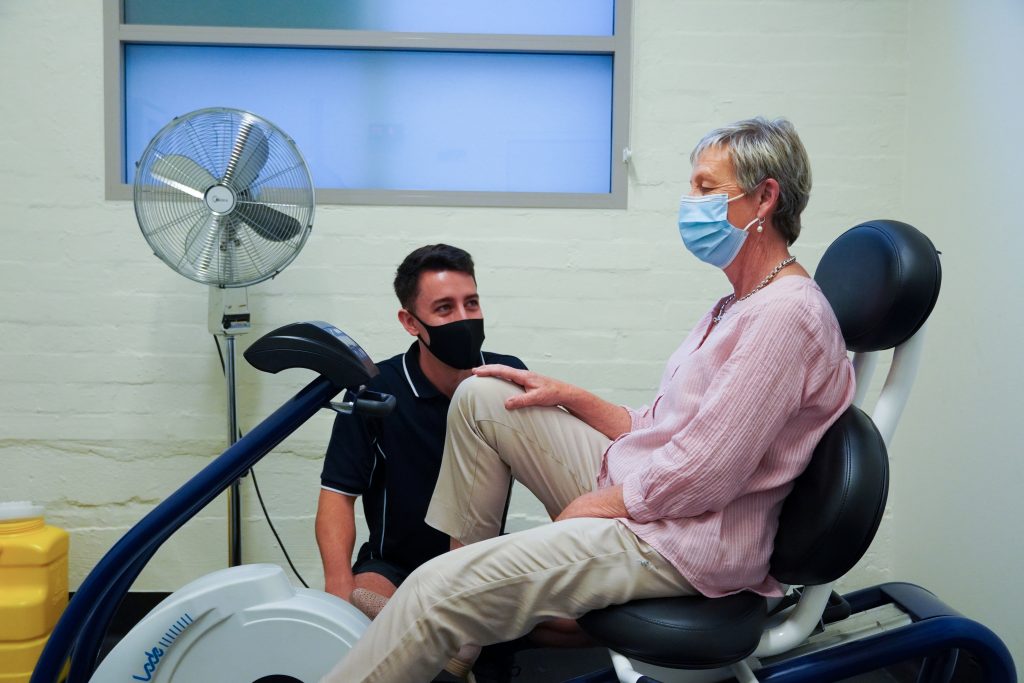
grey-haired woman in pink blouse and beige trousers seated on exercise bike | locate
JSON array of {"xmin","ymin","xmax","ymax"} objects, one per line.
[{"xmin": 328, "ymin": 118, "xmax": 854, "ymax": 683}]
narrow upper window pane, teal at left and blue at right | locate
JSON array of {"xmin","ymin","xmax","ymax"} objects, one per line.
[{"xmin": 124, "ymin": 0, "xmax": 614, "ymax": 36}]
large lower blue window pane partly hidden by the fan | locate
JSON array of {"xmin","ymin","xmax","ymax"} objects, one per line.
[{"xmin": 123, "ymin": 44, "xmax": 612, "ymax": 194}]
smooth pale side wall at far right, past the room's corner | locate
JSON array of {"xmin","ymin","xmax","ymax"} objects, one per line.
[{"xmin": 892, "ymin": 0, "xmax": 1024, "ymax": 671}]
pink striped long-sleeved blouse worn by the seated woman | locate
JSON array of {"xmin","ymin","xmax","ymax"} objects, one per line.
[{"xmin": 598, "ymin": 275, "xmax": 854, "ymax": 597}]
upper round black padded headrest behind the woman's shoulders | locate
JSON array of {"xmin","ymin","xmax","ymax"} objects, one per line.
[{"xmin": 814, "ymin": 220, "xmax": 942, "ymax": 351}]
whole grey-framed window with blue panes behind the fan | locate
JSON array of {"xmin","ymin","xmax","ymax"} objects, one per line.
[{"xmin": 105, "ymin": 0, "xmax": 631, "ymax": 208}]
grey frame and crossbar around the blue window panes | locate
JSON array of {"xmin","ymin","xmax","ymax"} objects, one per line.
[{"xmin": 103, "ymin": 0, "xmax": 633, "ymax": 209}]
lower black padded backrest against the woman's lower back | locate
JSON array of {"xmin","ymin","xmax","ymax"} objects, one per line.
[{"xmin": 771, "ymin": 405, "xmax": 889, "ymax": 586}]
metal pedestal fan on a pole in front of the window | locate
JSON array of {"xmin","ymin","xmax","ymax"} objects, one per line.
[{"xmin": 134, "ymin": 108, "xmax": 314, "ymax": 566}]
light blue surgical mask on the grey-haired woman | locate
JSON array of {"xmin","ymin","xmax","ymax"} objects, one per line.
[{"xmin": 679, "ymin": 195, "xmax": 758, "ymax": 268}]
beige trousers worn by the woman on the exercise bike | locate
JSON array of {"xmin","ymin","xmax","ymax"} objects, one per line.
[{"xmin": 324, "ymin": 378, "xmax": 695, "ymax": 683}]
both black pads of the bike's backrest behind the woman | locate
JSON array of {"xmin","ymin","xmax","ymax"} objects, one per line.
[{"xmin": 771, "ymin": 220, "xmax": 942, "ymax": 585}]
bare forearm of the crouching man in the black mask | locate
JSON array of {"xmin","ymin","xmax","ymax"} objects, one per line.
[{"xmin": 316, "ymin": 488, "xmax": 355, "ymax": 600}]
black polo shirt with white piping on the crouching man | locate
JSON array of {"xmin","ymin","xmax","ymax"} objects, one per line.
[{"xmin": 321, "ymin": 341, "xmax": 526, "ymax": 571}]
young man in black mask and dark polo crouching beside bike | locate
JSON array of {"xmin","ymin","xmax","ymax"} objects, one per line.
[{"xmin": 316, "ymin": 244, "xmax": 525, "ymax": 618}]
